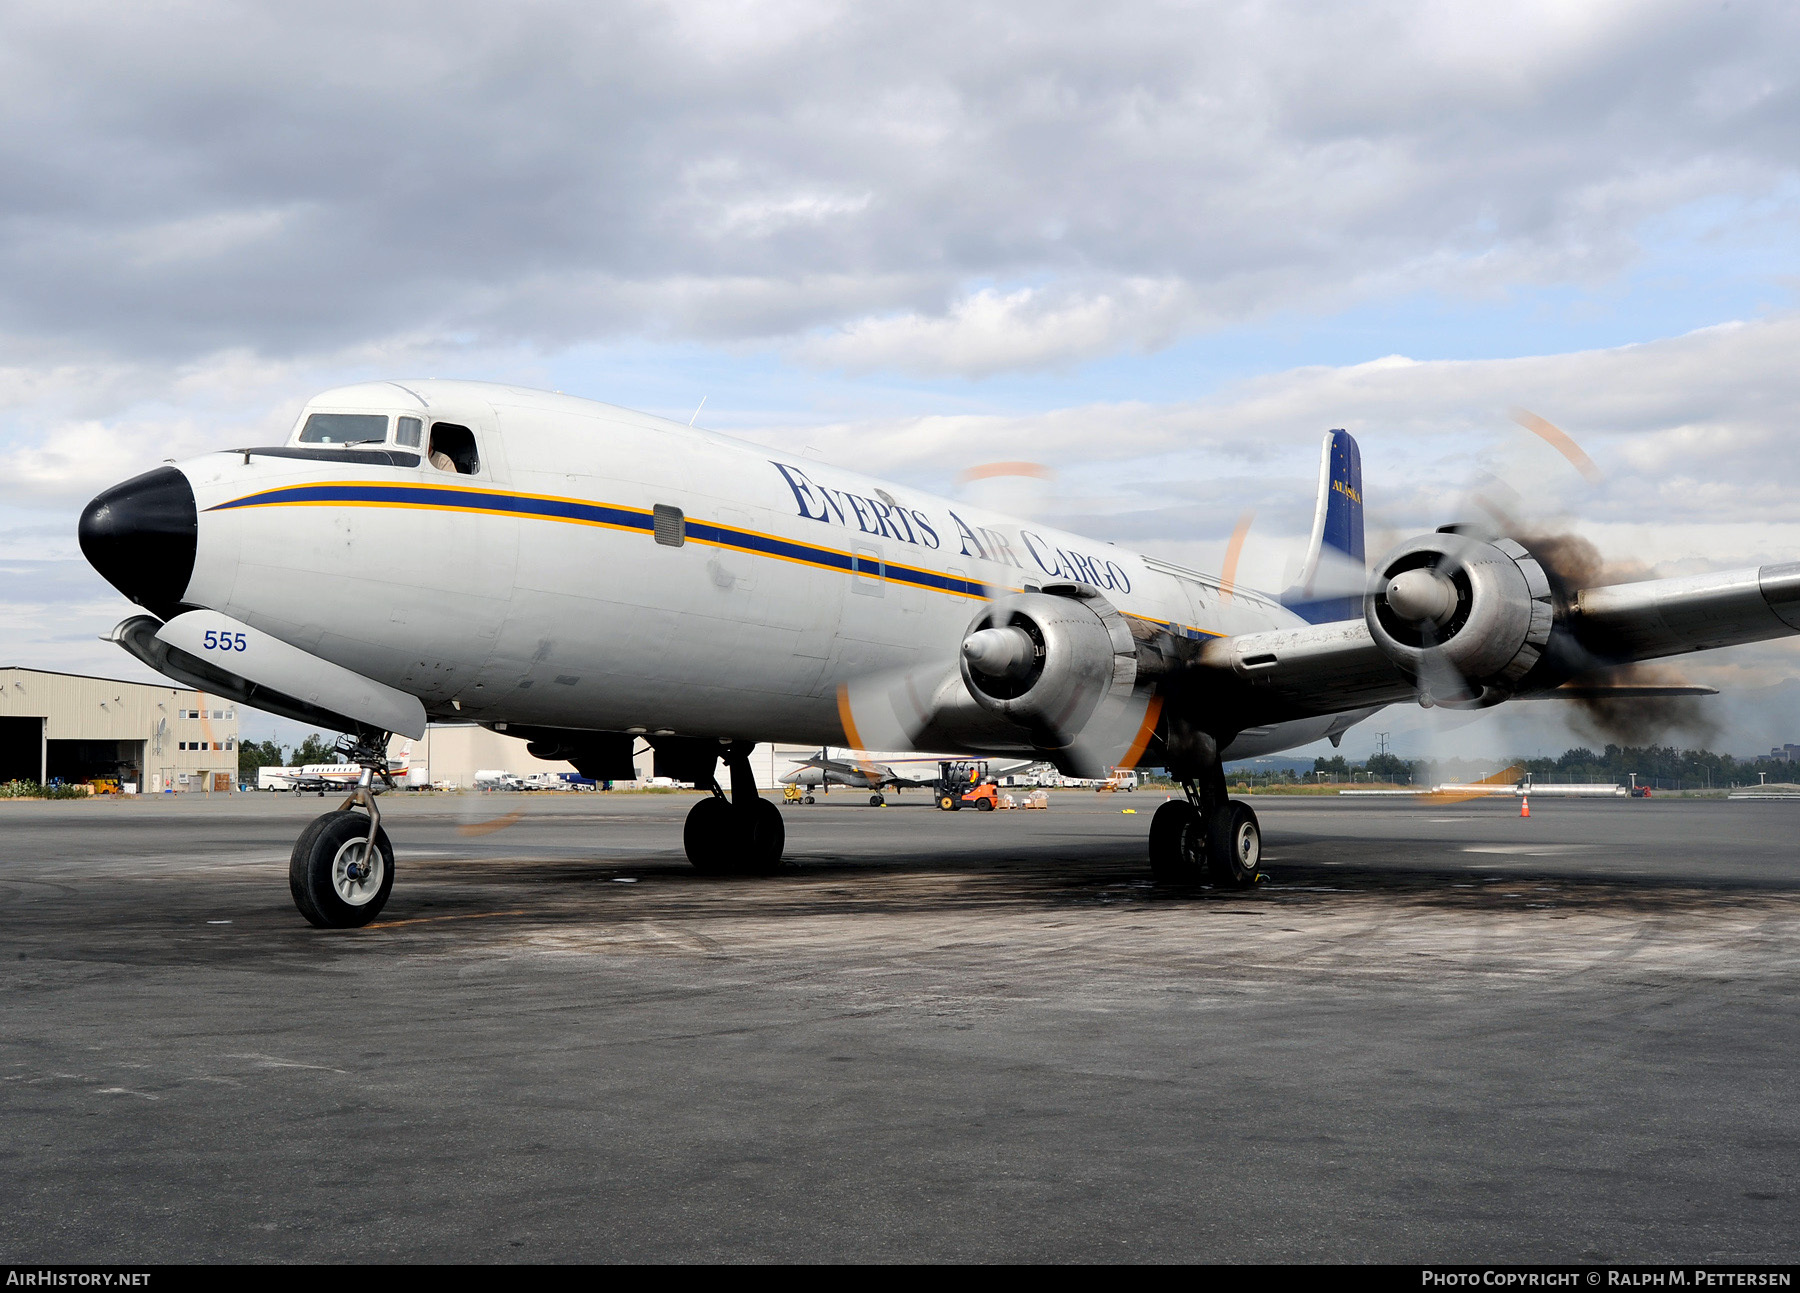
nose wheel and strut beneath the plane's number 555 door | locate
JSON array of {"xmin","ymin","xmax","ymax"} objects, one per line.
[{"xmin": 288, "ymin": 731, "xmax": 394, "ymax": 929}]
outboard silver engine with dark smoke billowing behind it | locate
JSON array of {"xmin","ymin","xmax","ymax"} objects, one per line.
[{"xmin": 1363, "ymin": 531, "xmax": 1555, "ymax": 708}]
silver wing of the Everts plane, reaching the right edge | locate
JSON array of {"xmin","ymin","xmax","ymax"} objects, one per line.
[{"xmin": 1183, "ymin": 558, "xmax": 1800, "ymax": 726}]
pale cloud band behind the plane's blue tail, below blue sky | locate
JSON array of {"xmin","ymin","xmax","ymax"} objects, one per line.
[{"xmin": 760, "ymin": 315, "xmax": 1800, "ymax": 582}]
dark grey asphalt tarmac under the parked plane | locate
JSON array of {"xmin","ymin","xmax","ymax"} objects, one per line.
[{"xmin": 0, "ymin": 792, "xmax": 1800, "ymax": 1264}]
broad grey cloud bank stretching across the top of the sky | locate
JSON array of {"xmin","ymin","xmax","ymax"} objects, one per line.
[{"xmin": 0, "ymin": 0, "xmax": 1800, "ymax": 375}]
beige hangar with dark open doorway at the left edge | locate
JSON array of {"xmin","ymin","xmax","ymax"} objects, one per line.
[{"xmin": 0, "ymin": 668, "xmax": 238, "ymax": 794}]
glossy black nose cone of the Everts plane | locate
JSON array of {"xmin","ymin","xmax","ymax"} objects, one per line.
[{"xmin": 81, "ymin": 466, "xmax": 200, "ymax": 619}]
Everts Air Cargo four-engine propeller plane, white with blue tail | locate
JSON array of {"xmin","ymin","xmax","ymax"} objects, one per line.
[{"xmin": 81, "ymin": 380, "xmax": 1800, "ymax": 926}]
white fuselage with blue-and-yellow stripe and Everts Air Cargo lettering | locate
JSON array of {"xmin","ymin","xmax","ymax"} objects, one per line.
[{"xmin": 180, "ymin": 382, "xmax": 1328, "ymax": 756}]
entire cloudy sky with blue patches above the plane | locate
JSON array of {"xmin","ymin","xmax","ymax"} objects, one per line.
[{"xmin": 0, "ymin": 0, "xmax": 1800, "ymax": 759}]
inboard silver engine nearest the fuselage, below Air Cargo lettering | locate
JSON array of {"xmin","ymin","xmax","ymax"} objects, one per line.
[{"xmin": 959, "ymin": 583, "xmax": 1138, "ymax": 749}]
